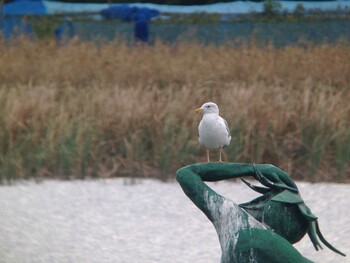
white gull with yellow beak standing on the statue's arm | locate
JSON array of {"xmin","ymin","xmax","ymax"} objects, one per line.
[{"xmin": 195, "ymin": 102, "xmax": 231, "ymax": 162}]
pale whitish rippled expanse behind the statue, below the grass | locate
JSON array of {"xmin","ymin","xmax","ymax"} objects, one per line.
[{"xmin": 0, "ymin": 179, "xmax": 350, "ymax": 263}]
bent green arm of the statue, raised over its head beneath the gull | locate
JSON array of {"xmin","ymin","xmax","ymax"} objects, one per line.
[{"xmin": 176, "ymin": 163, "xmax": 298, "ymax": 222}]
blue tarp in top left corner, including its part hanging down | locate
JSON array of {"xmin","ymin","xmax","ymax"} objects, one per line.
[{"xmin": 0, "ymin": 0, "xmax": 47, "ymax": 40}]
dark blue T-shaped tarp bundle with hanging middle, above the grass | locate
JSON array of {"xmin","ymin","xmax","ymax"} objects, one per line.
[{"xmin": 101, "ymin": 5, "xmax": 160, "ymax": 43}]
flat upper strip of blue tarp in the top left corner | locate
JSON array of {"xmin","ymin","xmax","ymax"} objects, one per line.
[{"xmin": 4, "ymin": 0, "xmax": 47, "ymax": 16}]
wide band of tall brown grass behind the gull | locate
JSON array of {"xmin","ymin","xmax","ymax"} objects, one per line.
[{"xmin": 0, "ymin": 41, "xmax": 350, "ymax": 181}]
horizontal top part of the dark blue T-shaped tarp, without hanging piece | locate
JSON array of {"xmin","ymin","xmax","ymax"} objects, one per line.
[{"xmin": 101, "ymin": 5, "xmax": 159, "ymax": 22}]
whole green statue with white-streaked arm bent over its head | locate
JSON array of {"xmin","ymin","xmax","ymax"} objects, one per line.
[{"xmin": 177, "ymin": 163, "xmax": 345, "ymax": 263}]
